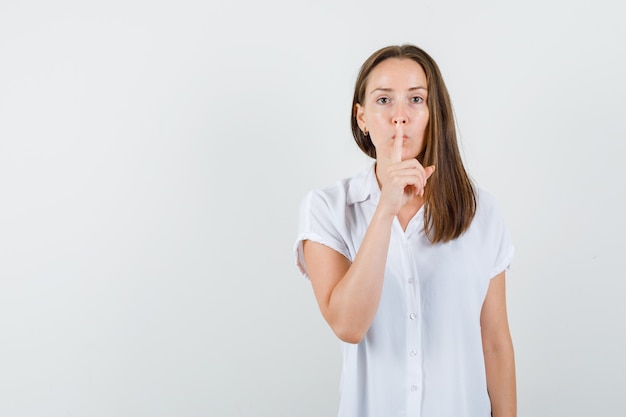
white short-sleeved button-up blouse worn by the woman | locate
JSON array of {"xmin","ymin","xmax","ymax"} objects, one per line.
[{"xmin": 295, "ymin": 166, "xmax": 513, "ymax": 417}]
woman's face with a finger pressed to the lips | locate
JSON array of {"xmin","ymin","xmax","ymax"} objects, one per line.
[{"xmin": 356, "ymin": 58, "xmax": 429, "ymax": 160}]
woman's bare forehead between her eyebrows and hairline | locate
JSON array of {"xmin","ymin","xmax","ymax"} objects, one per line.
[{"xmin": 366, "ymin": 58, "xmax": 427, "ymax": 90}]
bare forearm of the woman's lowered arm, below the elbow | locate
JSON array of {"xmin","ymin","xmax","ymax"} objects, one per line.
[{"xmin": 484, "ymin": 340, "xmax": 517, "ymax": 417}]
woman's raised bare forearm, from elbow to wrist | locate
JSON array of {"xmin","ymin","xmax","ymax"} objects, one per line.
[{"xmin": 327, "ymin": 210, "xmax": 395, "ymax": 343}]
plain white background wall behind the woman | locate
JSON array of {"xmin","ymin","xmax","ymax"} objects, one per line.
[{"xmin": 0, "ymin": 0, "xmax": 626, "ymax": 417}]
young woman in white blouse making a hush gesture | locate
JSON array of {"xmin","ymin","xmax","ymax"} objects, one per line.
[{"xmin": 296, "ymin": 45, "xmax": 516, "ymax": 417}]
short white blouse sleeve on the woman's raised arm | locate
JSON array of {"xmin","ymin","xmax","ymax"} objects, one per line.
[{"xmin": 294, "ymin": 191, "xmax": 350, "ymax": 279}]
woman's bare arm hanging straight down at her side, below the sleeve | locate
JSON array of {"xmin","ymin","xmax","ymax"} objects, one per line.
[{"xmin": 480, "ymin": 272, "xmax": 517, "ymax": 417}]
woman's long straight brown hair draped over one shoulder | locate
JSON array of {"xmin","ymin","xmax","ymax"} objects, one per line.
[{"xmin": 351, "ymin": 44, "xmax": 476, "ymax": 243}]
